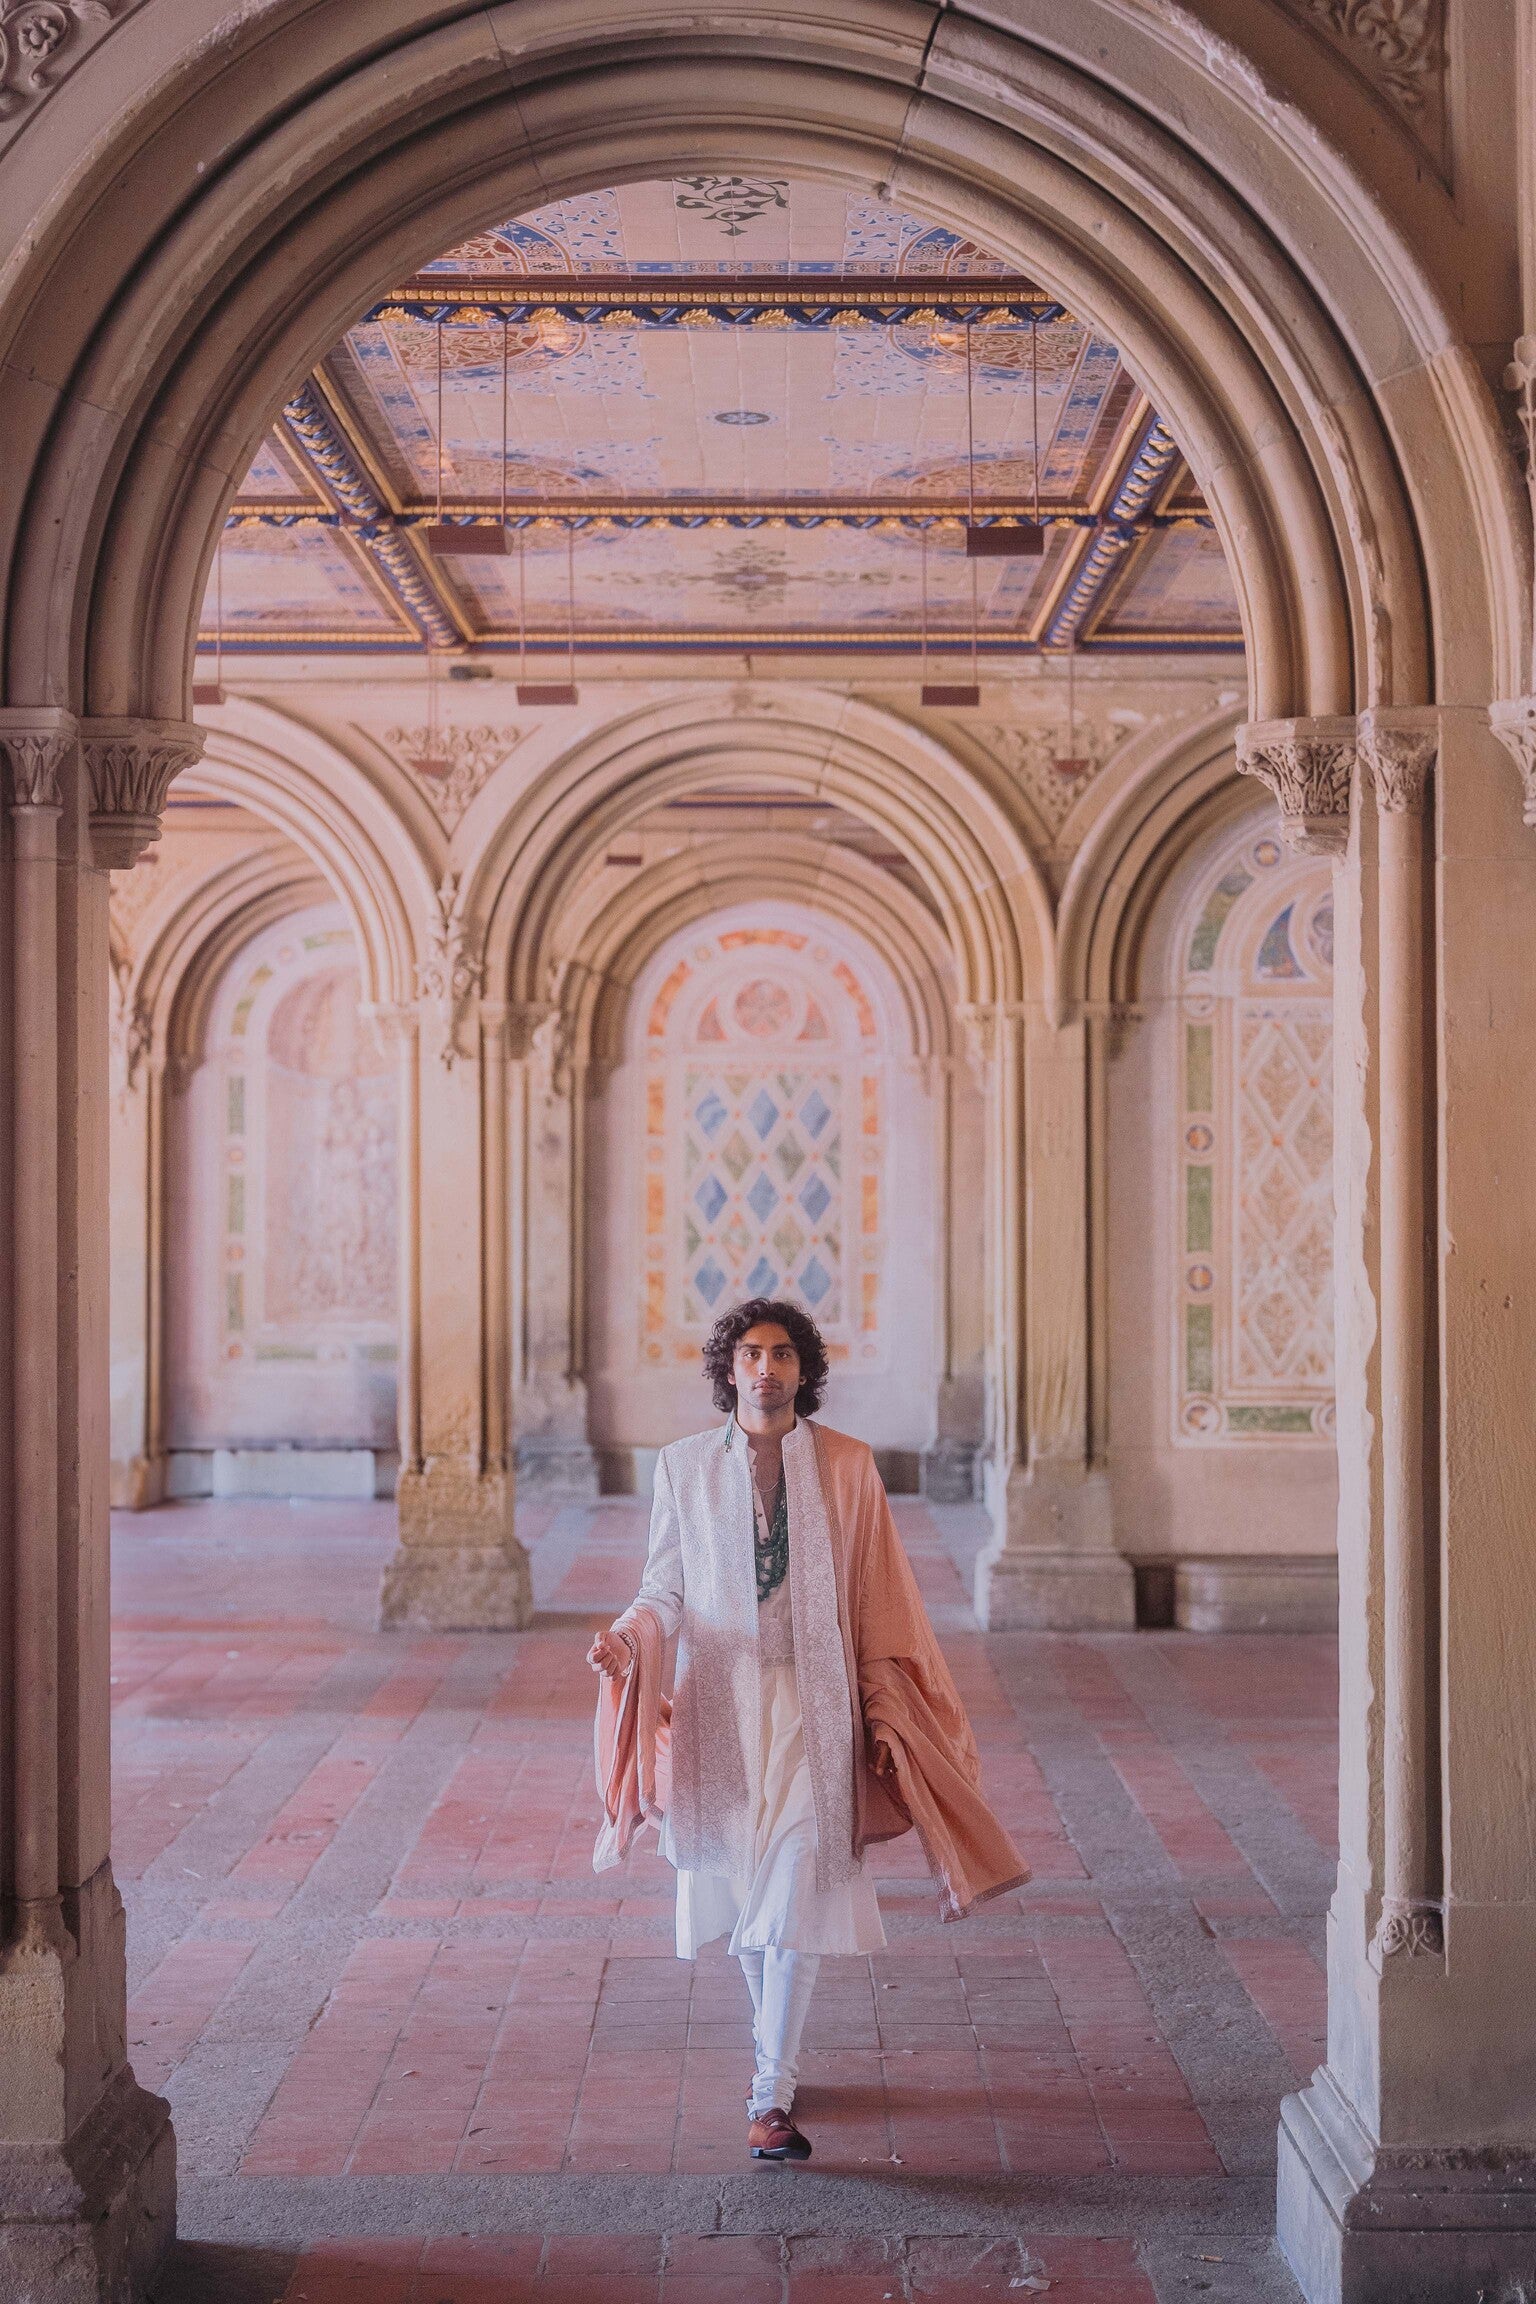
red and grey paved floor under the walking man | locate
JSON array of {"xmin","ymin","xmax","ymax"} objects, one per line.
[{"xmin": 113, "ymin": 1502, "xmax": 1333, "ymax": 2304}]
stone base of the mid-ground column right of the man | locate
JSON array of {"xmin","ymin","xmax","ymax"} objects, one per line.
[{"xmin": 976, "ymin": 1465, "xmax": 1135, "ymax": 1631}]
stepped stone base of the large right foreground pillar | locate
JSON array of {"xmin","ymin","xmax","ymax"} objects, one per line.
[{"xmin": 1278, "ymin": 2067, "xmax": 1536, "ymax": 2304}]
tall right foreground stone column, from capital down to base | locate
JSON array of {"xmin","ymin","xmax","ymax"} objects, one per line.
[{"xmin": 1278, "ymin": 707, "xmax": 1536, "ymax": 2304}]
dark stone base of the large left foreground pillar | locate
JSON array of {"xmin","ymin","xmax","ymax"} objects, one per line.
[{"xmin": 0, "ymin": 2067, "xmax": 175, "ymax": 2304}]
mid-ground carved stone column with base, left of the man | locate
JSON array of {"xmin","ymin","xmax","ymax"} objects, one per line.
[{"xmin": 380, "ymin": 878, "xmax": 532, "ymax": 1631}]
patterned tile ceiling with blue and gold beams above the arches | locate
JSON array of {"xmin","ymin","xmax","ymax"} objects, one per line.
[{"xmin": 205, "ymin": 177, "xmax": 1241, "ymax": 670}]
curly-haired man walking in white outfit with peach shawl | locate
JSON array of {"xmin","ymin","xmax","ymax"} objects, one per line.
[{"xmin": 587, "ymin": 1297, "xmax": 1027, "ymax": 2161}]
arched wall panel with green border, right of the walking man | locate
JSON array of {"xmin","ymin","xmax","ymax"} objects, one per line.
[{"xmin": 1174, "ymin": 827, "xmax": 1333, "ymax": 1445}]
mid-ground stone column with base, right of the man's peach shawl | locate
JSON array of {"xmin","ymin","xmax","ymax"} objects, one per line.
[{"xmin": 976, "ymin": 1007, "xmax": 1135, "ymax": 1631}]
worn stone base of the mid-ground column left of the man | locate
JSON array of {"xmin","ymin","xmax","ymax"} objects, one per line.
[{"xmin": 378, "ymin": 1458, "xmax": 534, "ymax": 1631}]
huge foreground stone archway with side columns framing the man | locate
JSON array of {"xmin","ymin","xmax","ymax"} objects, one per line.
[{"xmin": 0, "ymin": 0, "xmax": 1536, "ymax": 2297}]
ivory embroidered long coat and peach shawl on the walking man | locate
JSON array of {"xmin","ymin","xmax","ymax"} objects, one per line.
[{"xmin": 599, "ymin": 1419, "xmax": 1027, "ymax": 1949}]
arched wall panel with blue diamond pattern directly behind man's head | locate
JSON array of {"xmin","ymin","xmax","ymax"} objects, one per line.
[{"xmin": 640, "ymin": 926, "xmax": 889, "ymax": 1366}]
